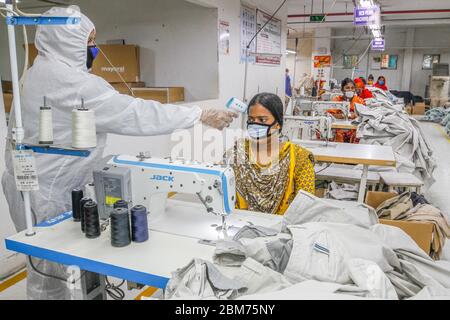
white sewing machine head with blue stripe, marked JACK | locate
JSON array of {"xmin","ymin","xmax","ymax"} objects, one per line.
[{"xmin": 94, "ymin": 154, "xmax": 236, "ymax": 218}]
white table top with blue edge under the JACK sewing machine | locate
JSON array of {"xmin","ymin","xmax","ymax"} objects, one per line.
[{"xmin": 6, "ymin": 200, "xmax": 281, "ymax": 288}]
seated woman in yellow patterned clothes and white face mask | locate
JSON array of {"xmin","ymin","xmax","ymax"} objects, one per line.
[{"xmin": 227, "ymin": 93, "xmax": 315, "ymax": 215}]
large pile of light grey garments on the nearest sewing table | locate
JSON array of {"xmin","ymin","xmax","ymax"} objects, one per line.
[{"xmin": 165, "ymin": 192, "xmax": 450, "ymax": 299}]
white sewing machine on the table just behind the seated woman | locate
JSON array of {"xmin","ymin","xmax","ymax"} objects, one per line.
[{"xmin": 283, "ymin": 116, "xmax": 333, "ymax": 141}]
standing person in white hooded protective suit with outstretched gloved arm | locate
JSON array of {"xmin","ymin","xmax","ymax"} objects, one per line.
[{"xmin": 2, "ymin": 7, "xmax": 236, "ymax": 299}]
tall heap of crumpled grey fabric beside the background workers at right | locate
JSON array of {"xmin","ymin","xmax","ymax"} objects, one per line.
[{"xmin": 356, "ymin": 105, "xmax": 436, "ymax": 184}]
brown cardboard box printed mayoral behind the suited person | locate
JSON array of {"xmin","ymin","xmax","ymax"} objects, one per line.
[{"xmin": 28, "ymin": 44, "xmax": 141, "ymax": 83}]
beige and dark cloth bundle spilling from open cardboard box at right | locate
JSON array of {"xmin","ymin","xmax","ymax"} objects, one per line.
[{"xmin": 376, "ymin": 192, "xmax": 450, "ymax": 259}]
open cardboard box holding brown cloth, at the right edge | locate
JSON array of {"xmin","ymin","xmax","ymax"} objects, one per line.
[{"xmin": 366, "ymin": 191, "xmax": 434, "ymax": 254}]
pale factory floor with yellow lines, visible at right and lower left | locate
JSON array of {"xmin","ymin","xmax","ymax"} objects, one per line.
[{"xmin": 0, "ymin": 122, "xmax": 450, "ymax": 300}]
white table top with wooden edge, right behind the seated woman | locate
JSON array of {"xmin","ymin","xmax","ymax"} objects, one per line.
[{"xmin": 293, "ymin": 140, "xmax": 396, "ymax": 167}]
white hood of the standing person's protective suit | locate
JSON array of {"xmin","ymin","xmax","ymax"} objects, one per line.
[{"xmin": 35, "ymin": 6, "xmax": 95, "ymax": 71}]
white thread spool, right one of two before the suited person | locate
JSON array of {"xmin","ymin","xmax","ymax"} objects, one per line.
[{"xmin": 72, "ymin": 105, "xmax": 97, "ymax": 149}]
